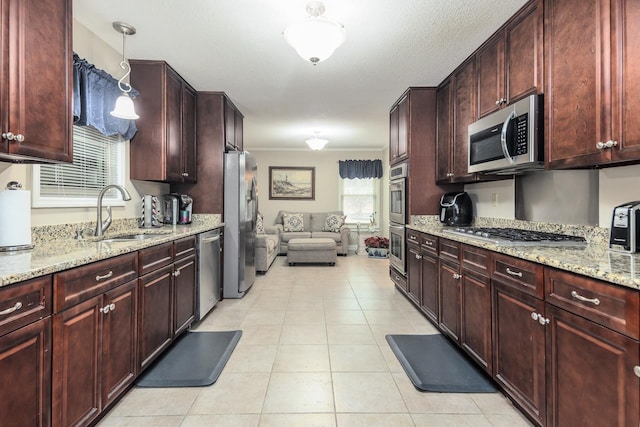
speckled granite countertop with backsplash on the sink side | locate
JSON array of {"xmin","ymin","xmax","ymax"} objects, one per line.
[{"xmin": 0, "ymin": 215, "xmax": 224, "ymax": 287}]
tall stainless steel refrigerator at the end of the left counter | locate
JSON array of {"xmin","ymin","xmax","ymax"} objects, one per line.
[{"xmin": 222, "ymin": 151, "xmax": 258, "ymax": 298}]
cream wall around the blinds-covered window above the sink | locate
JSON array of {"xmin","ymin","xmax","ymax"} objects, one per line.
[{"xmin": 0, "ymin": 20, "xmax": 169, "ymax": 226}]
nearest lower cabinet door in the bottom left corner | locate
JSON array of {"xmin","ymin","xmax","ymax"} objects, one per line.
[{"xmin": 0, "ymin": 318, "xmax": 51, "ymax": 427}]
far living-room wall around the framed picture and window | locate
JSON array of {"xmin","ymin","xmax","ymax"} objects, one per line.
[{"xmin": 248, "ymin": 148, "xmax": 389, "ymax": 233}]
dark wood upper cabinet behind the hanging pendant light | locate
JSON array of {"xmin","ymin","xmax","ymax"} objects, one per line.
[{"xmin": 130, "ymin": 60, "xmax": 197, "ymax": 182}]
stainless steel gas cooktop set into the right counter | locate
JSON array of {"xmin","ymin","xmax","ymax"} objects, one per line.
[{"xmin": 444, "ymin": 227, "xmax": 587, "ymax": 246}]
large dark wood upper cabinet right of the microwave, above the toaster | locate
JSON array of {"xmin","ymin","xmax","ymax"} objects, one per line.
[{"xmin": 545, "ymin": 0, "xmax": 640, "ymax": 168}]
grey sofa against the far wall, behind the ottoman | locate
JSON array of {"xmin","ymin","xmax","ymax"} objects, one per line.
[{"xmin": 275, "ymin": 211, "xmax": 351, "ymax": 256}]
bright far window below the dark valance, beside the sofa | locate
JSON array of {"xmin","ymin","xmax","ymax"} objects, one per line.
[{"xmin": 340, "ymin": 178, "xmax": 380, "ymax": 225}]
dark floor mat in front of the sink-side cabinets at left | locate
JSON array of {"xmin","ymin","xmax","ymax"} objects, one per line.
[{"xmin": 136, "ymin": 331, "xmax": 242, "ymax": 387}]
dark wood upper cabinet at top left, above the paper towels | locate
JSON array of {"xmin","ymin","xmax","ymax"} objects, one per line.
[{"xmin": 0, "ymin": 0, "xmax": 73, "ymax": 163}]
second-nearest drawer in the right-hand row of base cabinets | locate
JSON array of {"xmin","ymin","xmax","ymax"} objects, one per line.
[{"xmin": 491, "ymin": 253, "xmax": 544, "ymax": 299}]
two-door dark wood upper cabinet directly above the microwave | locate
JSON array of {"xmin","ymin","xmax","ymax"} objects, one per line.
[{"xmin": 476, "ymin": 0, "xmax": 544, "ymax": 118}]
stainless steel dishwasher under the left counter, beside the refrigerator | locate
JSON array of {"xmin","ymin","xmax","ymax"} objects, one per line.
[{"xmin": 196, "ymin": 229, "xmax": 222, "ymax": 320}]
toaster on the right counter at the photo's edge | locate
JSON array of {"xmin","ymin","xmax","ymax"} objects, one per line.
[{"xmin": 609, "ymin": 201, "xmax": 640, "ymax": 253}]
